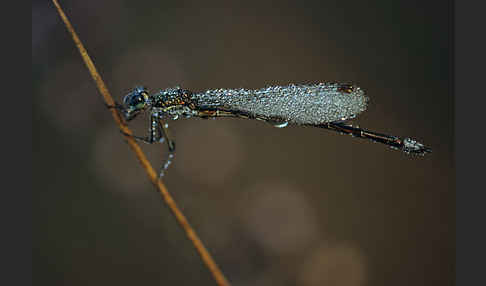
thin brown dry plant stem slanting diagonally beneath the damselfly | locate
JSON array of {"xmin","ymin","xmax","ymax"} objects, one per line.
[{"xmin": 52, "ymin": 0, "xmax": 230, "ymax": 285}]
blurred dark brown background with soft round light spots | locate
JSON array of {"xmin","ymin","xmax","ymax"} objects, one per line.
[{"xmin": 32, "ymin": 0, "xmax": 455, "ymax": 286}]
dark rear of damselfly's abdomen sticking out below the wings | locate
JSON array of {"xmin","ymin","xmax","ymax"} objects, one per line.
[{"xmin": 318, "ymin": 122, "xmax": 432, "ymax": 155}]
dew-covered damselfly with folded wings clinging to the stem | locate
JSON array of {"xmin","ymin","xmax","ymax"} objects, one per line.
[{"xmin": 109, "ymin": 83, "xmax": 431, "ymax": 176}]
